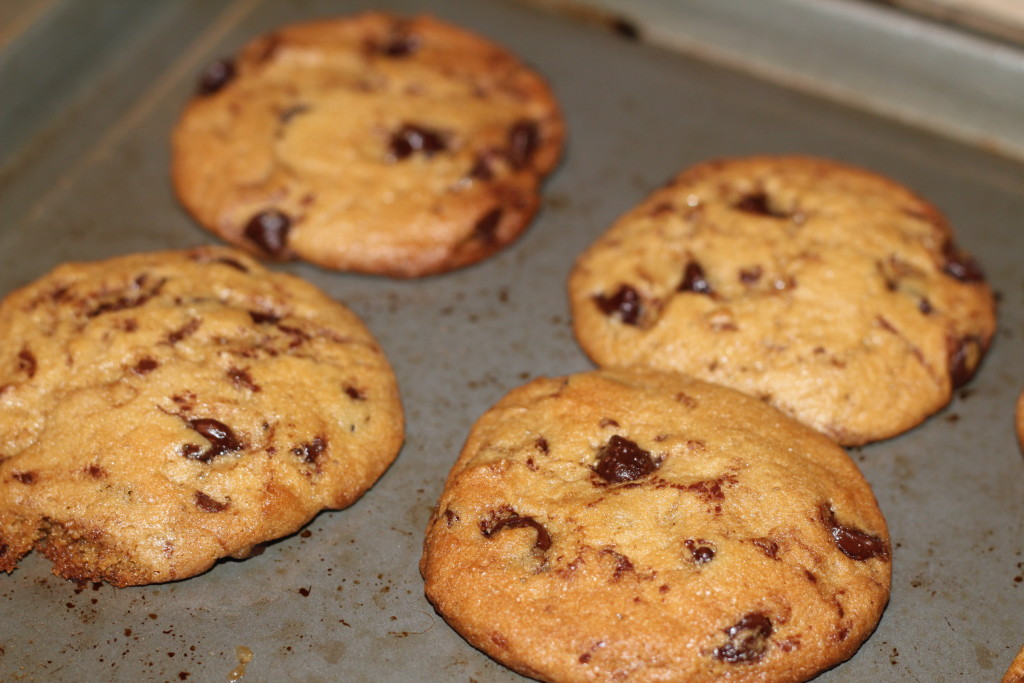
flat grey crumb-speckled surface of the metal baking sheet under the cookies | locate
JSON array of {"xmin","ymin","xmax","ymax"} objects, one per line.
[{"xmin": 0, "ymin": 0, "xmax": 1024, "ymax": 682}]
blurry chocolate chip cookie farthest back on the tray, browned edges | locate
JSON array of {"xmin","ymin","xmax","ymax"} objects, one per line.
[{"xmin": 172, "ymin": 12, "xmax": 564, "ymax": 278}]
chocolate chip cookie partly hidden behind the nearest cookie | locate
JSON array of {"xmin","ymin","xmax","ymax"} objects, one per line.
[{"xmin": 568, "ymin": 157, "xmax": 995, "ymax": 445}]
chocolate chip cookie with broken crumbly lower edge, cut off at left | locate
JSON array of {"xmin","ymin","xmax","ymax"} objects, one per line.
[{"xmin": 0, "ymin": 248, "xmax": 403, "ymax": 586}]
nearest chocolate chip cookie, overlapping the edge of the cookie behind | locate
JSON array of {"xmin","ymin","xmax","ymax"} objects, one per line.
[{"xmin": 420, "ymin": 369, "xmax": 891, "ymax": 681}]
